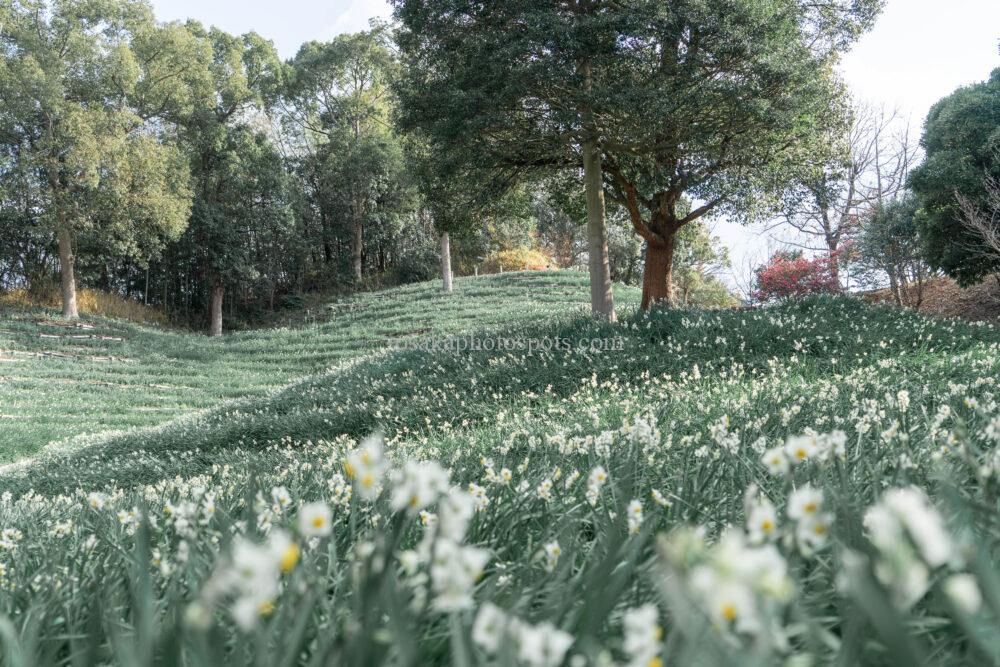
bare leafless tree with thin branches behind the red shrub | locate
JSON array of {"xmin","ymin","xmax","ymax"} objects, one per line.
[{"xmin": 781, "ymin": 105, "xmax": 916, "ymax": 284}]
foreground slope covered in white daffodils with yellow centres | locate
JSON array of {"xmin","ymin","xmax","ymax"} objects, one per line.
[{"xmin": 0, "ymin": 275, "xmax": 1000, "ymax": 666}]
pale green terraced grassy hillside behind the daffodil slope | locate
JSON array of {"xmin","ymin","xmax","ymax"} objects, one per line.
[{"xmin": 0, "ymin": 273, "xmax": 636, "ymax": 463}]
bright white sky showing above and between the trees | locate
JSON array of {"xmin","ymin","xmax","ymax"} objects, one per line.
[{"xmin": 152, "ymin": 0, "xmax": 1000, "ymax": 287}]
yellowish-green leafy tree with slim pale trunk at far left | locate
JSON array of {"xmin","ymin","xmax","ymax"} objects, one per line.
[{"xmin": 0, "ymin": 0, "xmax": 197, "ymax": 318}]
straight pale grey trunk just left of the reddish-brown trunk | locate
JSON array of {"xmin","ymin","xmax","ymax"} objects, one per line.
[{"xmin": 582, "ymin": 136, "xmax": 617, "ymax": 322}]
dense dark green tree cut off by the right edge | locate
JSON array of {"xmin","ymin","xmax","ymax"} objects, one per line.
[{"xmin": 910, "ymin": 69, "xmax": 1000, "ymax": 286}]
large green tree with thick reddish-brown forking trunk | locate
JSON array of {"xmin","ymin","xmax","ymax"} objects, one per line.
[{"xmin": 602, "ymin": 0, "xmax": 881, "ymax": 308}]
